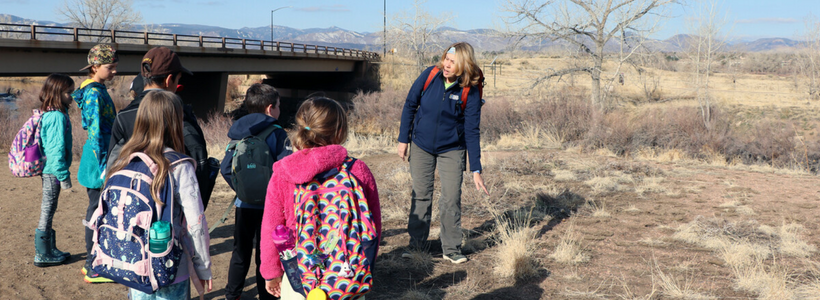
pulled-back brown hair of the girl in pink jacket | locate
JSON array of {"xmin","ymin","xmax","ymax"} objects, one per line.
[{"xmin": 290, "ymin": 97, "xmax": 347, "ymax": 150}]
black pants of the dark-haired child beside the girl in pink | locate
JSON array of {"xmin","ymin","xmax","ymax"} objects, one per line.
[{"xmin": 225, "ymin": 207, "xmax": 276, "ymax": 299}]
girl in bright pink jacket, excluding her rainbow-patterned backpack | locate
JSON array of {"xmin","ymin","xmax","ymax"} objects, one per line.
[{"xmin": 260, "ymin": 97, "xmax": 381, "ymax": 300}]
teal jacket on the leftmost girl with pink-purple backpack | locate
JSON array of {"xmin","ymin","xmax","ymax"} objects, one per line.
[{"xmin": 40, "ymin": 110, "xmax": 73, "ymax": 181}]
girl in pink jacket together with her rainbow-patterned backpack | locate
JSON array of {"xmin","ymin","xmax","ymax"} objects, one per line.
[{"xmin": 260, "ymin": 97, "xmax": 381, "ymax": 300}]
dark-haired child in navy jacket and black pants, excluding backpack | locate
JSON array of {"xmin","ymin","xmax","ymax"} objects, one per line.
[{"xmin": 221, "ymin": 83, "xmax": 291, "ymax": 300}]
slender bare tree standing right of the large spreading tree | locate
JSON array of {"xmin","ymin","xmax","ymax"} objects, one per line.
[{"xmin": 689, "ymin": 0, "xmax": 727, "ymax": 129}]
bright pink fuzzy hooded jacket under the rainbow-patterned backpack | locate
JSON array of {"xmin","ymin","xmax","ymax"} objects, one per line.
[{"xmin": 259, "ymin": 145, "xmax": 382, "ymax": 280}]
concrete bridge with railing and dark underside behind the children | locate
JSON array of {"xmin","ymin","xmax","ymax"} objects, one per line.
[{"xmin": 0, "ymin": 23, "xmax": 379, "ymax": 116}]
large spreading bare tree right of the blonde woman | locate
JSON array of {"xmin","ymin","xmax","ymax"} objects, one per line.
[{"xmin": 504, "ymin": 0, "xmax": 682, "ymax": 108}]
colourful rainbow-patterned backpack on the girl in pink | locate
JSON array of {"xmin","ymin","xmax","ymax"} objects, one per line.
[{"xmin": 293, "ymin": 157, "xmax": 379, "ymax": 300}]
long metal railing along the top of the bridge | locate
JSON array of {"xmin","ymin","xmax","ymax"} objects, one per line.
[{"xmin": 0, "ymin": 23, "xmax": 379, "ymax": 59}]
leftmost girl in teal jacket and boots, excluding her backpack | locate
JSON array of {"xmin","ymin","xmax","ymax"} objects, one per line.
[{"xmin": 34, "ymin": 74, "xmax": 74, "ymax": 267}]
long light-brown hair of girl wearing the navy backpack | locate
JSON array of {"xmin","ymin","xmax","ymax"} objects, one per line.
[{"xmin": 108, "ymin": 91, "xmax": 185, "ymax": 204}]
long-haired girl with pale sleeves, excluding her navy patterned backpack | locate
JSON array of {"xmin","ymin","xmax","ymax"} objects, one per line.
[{"xmin": 110, "ymin": 91, "xmax": 212, "ymax": 300}]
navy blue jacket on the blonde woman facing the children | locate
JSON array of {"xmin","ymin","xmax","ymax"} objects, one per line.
[{"xmin": 398, "ymin": 67, "xmax": 481, "ymax": 172}]
